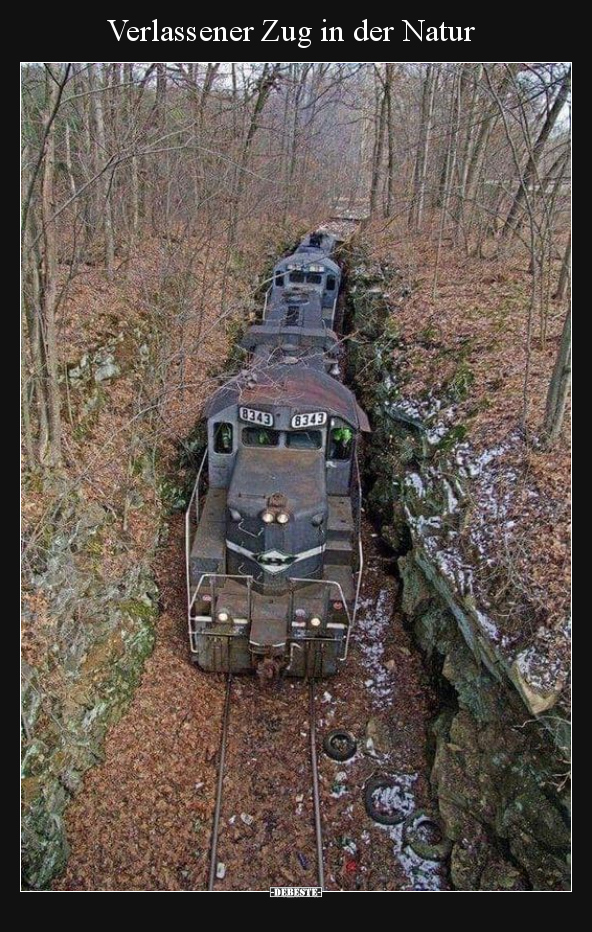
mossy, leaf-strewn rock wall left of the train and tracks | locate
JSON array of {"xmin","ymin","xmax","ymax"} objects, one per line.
[{"xmin": 22, "ymin": 330, "xmax": 163, "ymax": 890}]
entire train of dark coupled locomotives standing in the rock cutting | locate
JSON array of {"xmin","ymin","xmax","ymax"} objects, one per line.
[{"xmin": 185, "ymin": 230, "xmax": 370, "ymax": 679}]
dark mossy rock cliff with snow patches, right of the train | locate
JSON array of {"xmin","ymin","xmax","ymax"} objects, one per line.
[{"xmin": 349, "ymin": 250, "xmax": 570, "ymax": 890}]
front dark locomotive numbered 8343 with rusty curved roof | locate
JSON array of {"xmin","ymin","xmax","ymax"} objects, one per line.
[{"xmin": 188, "ymin": 366, "xmax": 369, "ymax": 675}]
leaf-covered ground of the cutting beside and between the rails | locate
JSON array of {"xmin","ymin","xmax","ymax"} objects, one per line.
[{"xmin": 53, "ymin": 519, "xmax": 443, "ymax": 891}]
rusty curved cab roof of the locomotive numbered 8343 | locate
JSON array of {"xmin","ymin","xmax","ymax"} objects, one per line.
[{"xmin": 204, "ymin": 364, "xmax": 370, "ymax": 431}]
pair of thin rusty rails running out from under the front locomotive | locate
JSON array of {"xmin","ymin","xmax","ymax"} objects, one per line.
[{"xmin": 208, "ymin": 674, "xmax": 325, "ymax": 891}]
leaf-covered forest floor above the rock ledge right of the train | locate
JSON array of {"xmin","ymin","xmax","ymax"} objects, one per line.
[{"xmin": 364, "ymin": 222, "xmax": 571, "ymax": 700}]
